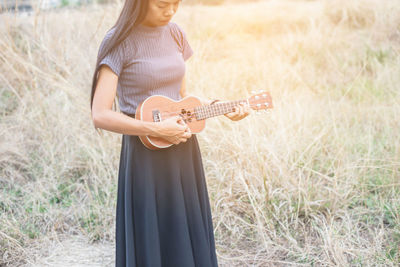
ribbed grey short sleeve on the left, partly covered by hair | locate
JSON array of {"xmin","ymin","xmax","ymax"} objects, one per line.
[{"xmin": 99, "ymin": 29, "xmax": 124, "ymax": 76}]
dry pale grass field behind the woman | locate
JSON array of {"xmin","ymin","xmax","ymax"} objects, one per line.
[{"xmin": 0, "ymin": 0, "xmax": 400, "ymax": 266}]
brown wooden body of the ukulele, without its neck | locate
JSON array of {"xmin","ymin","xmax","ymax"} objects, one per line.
[{"xmin": 135, "ymin": 95, "xmax": 206, "ymax": 150}]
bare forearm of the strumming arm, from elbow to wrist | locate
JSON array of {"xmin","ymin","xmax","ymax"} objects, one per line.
[{"xmin": 92, "ymin": 110, "xmax": 158, "ymax": 136}]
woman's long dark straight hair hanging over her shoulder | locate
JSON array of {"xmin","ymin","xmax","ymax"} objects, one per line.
[{"xmin": 90, "ymin": 0, "xmax": 149, "ymax": 109}]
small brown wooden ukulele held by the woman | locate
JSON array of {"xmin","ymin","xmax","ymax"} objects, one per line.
[{"xmin": 135, "ymin": 92, "xmax": 273, "ymax": 150}]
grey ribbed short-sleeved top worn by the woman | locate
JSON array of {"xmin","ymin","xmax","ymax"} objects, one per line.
[{"xmin": 100, "ymin": 22, "xmax": 193, "ymax": 114}]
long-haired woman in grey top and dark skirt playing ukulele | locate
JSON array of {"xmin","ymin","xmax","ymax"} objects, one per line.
[{"xmin": 91, "ymin": 0, "xmax": 250, "ymax": 267}]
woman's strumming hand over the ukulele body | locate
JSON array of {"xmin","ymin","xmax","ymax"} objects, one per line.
[{"xmin": 155, "ymin": 116, "xmax": 192, "ymax": 145}]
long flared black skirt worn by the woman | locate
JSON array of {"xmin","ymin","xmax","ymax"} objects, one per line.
[{"xmin": 115, "ymin": 135, "xmax": 218, "ymax": 267}]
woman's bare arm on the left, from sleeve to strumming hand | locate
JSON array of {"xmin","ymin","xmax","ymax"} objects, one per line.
[{"xmin": 92, "ymin": 65, "xmax": 190, "ymax": 144}]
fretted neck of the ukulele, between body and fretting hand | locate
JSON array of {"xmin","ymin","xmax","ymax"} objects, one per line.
[{"xmin": 194, "ymin": 100, "xmax": 247, "ymax": 120}]
